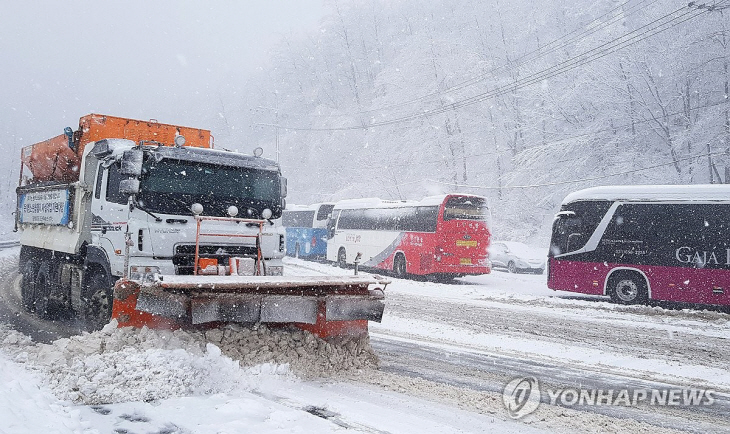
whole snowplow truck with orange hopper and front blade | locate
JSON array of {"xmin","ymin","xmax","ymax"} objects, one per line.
[{"xmin": 15, "ymin": 114, "xmax": 389, "ymax": 338}]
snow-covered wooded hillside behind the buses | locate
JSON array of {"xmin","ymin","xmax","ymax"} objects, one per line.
[{"xmin": 224, "ymin": 0, "xmax": 730, "ymax": 244}]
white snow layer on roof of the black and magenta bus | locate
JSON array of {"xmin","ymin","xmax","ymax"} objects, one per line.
[{"xmin": 563, "ymin": 184, "xmax": 730, "ymax": 204}]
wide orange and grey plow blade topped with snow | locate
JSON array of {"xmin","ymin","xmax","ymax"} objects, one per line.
[{"xmin": 112, "ymin": 274, "xmax": 390, "ymax": 338}]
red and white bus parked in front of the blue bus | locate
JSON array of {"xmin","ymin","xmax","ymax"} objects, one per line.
[{"xmin": 327, "ymin": 194, "xmax": 490, "ymax": 280}]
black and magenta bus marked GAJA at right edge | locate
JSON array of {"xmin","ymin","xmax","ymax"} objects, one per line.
[{"xmin": 548, "ymin": 185, "xmax": 730, "ymax": 305}]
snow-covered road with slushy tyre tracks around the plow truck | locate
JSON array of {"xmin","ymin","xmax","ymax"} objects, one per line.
[{"xmin": 0, "ymin": 251, "xmax": 730, "ymax": 433}]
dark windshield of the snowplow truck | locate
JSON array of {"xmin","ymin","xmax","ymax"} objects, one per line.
[{"xmin": 137, "ymin": 158, "xmax": 281, "ymax": 218}]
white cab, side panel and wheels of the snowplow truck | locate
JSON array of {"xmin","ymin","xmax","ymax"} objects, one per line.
[{"xmin": 16, "ymin": 139, "xmax": 286, "ymax": 326}]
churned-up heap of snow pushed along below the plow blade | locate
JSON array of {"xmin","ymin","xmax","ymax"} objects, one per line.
[{"xmin": 0, "ymin": 321, "xmax": 377, "ymax": 404}]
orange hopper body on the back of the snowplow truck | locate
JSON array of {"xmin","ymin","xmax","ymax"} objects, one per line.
[{"xmin": 21, "ymin": 114, "xmax": 213, "ymax": 183}]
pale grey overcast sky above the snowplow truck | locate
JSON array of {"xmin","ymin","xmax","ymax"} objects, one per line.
[{"xmin": 0, "ymin": 0, "xmax": 328, "ymax": 148}]
